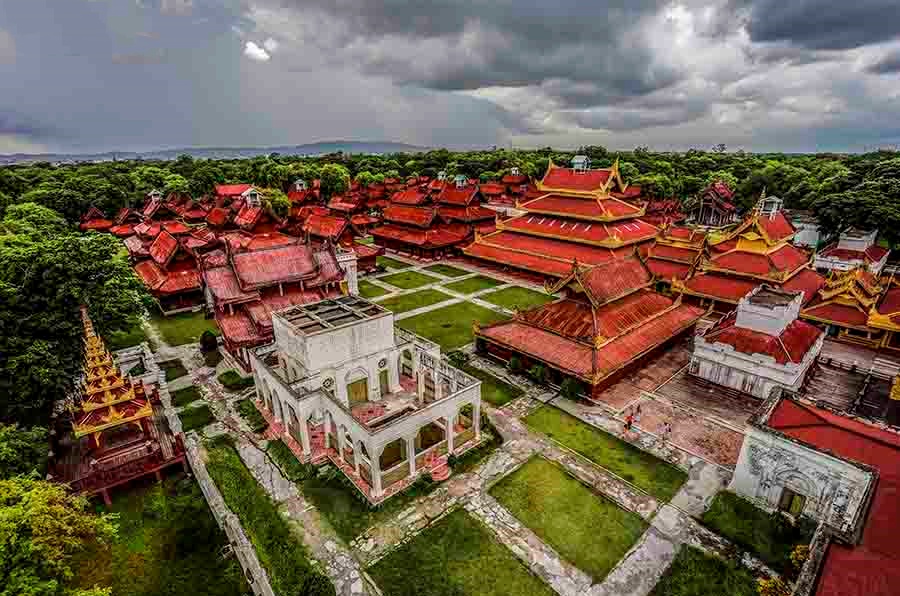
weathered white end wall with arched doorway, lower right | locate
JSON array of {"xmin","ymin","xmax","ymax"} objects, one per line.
[{"xmin": 729, "ymin": 426, "xmax": 875, "ymax": 532}]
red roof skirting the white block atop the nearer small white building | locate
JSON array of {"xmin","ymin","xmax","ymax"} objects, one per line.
[{"xmin": 703, "ymin": 312, "xmax": 822, "ymax": 364}]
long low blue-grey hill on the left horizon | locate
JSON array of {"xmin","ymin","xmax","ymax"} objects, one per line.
[{"xmin": 0, "ymin": 141, "xmax": 430, "ymax": 164}]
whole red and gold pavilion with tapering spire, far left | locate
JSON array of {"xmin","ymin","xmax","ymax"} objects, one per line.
[{"xmin": 50, "ymin": 307, "xmax": 185, "ymax": 503}]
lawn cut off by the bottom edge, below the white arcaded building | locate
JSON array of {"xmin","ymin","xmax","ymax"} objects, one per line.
[{"xmin": 368, "ymin": 509, "xmax": 555, "ymax": 596}]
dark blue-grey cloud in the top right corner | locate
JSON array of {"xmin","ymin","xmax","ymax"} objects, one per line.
[{"xmin": 734, "ymin": 0, "xmax": 900, "ymax": 50}]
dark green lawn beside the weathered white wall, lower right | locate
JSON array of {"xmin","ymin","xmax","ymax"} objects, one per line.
[{"xmin": 700, "ymin": 491, "xmax": 812, "ymax": 571}]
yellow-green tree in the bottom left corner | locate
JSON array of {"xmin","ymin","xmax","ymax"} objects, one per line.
[{"xmin": 0, "ymin": 476, "xmax": 116, "ymax": 596}]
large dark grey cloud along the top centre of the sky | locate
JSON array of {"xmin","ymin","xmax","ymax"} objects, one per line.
[{"xmin": 264, "ymin": 0, "xmax": 681, "ymax": 107}]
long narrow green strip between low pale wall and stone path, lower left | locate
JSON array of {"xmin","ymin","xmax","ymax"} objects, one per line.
[{"xmin": 207, "ymin": 443, "xmax": 335, "ymax": 596}]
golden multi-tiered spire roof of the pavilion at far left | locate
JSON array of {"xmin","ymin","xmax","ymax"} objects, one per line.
[{"xmin": 72, "ymin": 306, "xmax": 153, "ymax": 438}]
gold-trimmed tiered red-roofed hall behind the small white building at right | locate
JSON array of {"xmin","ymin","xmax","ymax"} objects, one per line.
[{"xmin": 672, "ymin": 201, "xmax": 825, "ymax": 311}]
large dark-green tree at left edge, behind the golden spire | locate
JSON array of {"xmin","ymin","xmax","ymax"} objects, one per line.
[{"xmin": 0, "ymin": 205, "xmax": 148, "ymax": 425}]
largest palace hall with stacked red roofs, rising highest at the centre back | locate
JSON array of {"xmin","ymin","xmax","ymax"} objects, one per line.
[{"xmin": 463, "ymin": 156, "xmax": 659, "ymax": 280}]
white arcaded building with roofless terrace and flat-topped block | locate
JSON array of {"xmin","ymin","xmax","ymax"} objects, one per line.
[{"xmin": 250, "ymin": 296, "xmax": 481, "ymax": 504}]
